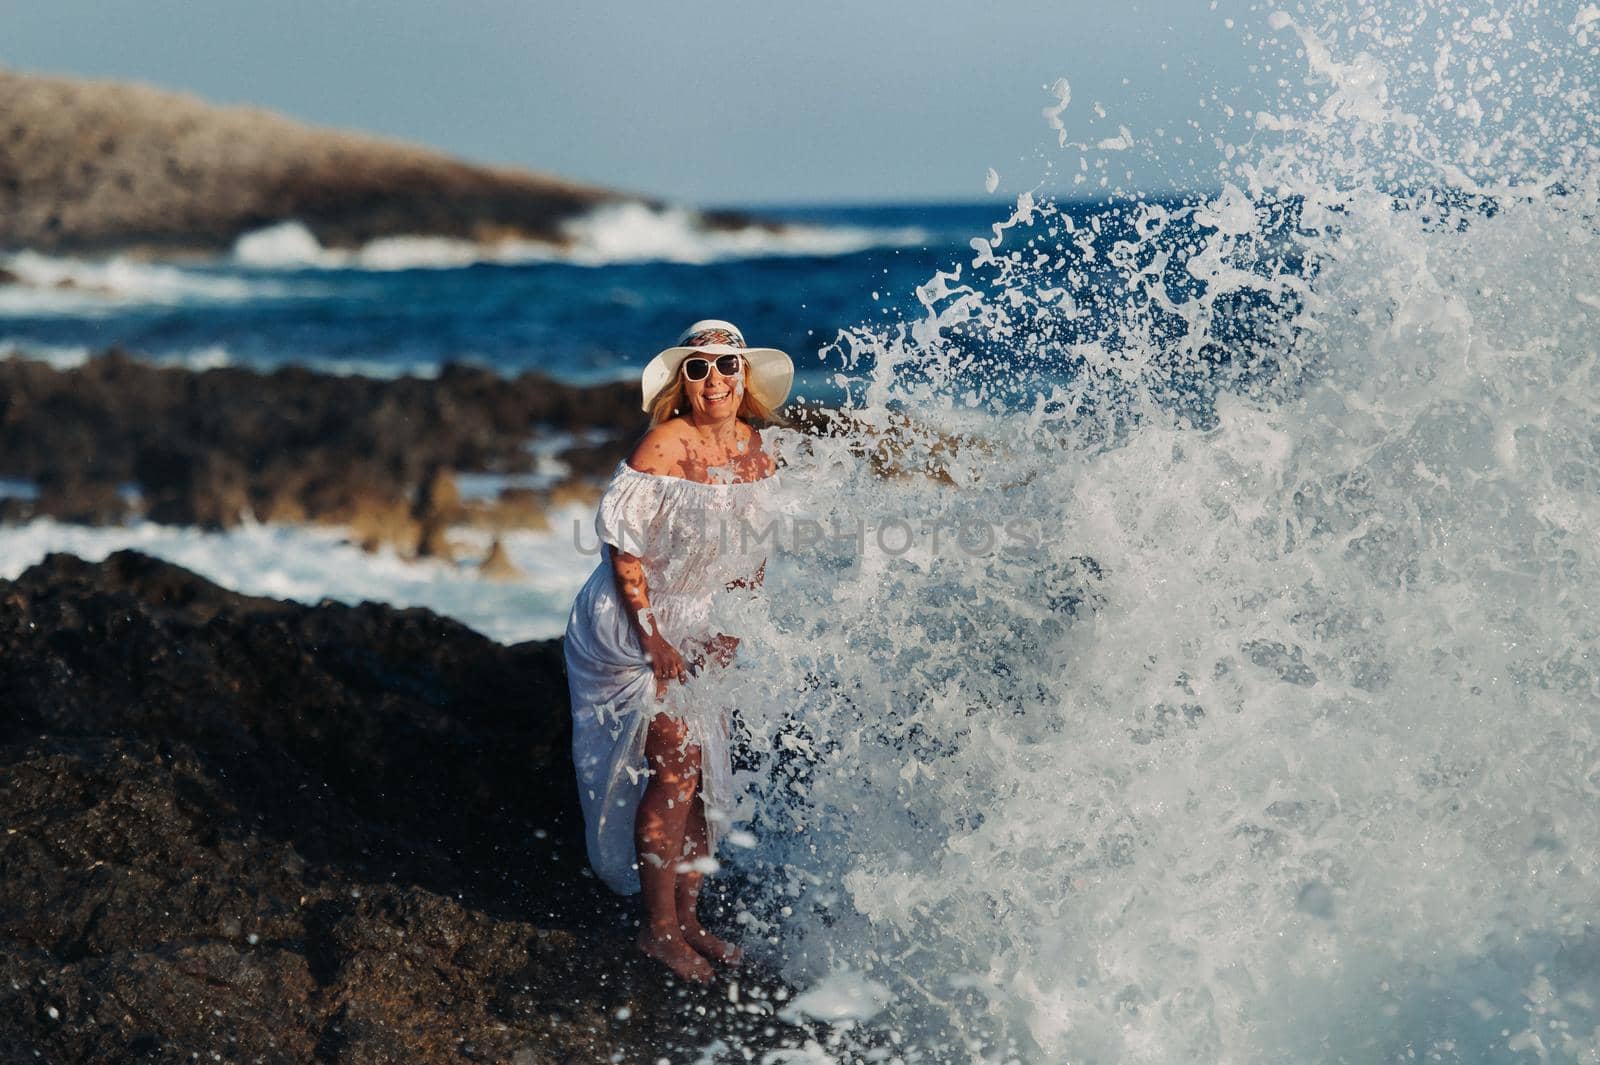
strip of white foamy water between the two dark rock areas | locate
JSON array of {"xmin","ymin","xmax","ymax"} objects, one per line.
[{"xmin": 0, "ymin": 511, "xmax": 597, "ymax": 643}]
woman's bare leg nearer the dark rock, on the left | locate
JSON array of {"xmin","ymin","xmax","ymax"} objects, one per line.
[{"xmin": 634, "ymin": 713, "xmax": 712, "ymax": 983}]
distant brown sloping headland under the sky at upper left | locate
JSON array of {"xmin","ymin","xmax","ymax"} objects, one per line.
[{"xmin": 0, "ymin": 70, "xmax": 627, "ymax": 253}]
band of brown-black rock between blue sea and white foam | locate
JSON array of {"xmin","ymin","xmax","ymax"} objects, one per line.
[{"xmin": 0, "ymin": 352, "xmax": 643, "ymax": 550}]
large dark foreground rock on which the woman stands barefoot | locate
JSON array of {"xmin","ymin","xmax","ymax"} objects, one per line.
[{"xmin": 0, "ymin": 553, "xmax": 792, "ymax": 1063}]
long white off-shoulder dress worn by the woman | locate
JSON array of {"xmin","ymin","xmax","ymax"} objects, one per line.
[{"xmin": 565, "ymin": 450, "xmax": 778, "ymax": 894}]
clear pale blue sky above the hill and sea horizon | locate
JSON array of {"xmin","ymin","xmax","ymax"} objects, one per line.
[{"xmin": 0, "ymin": 0, "xmax": 1254, "ymax": 205}]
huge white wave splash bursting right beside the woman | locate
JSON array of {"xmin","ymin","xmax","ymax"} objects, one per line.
[{"xmin": 713, "ymin": 3, "xmax": 1600, "ymax": 1062}]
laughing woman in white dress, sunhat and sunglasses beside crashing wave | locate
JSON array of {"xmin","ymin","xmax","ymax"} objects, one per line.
[{"xmin": 566, "ymin": 320, "xmax": 794, "ymax": 983}]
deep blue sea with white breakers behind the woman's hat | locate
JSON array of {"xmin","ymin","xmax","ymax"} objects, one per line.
[{"xmin": 0, "ymin": 203, "xmax": 1011, "ymax": 400}]
